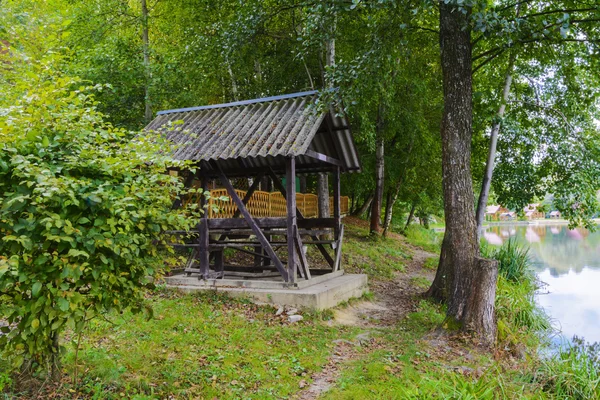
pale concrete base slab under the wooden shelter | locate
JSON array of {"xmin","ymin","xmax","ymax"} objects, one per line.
[{"xmin": 166, "ymin": 274, "xmax": 367, "ymax": 310}]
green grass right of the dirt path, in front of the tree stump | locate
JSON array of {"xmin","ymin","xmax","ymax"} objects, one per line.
[{"xmin": 324, "ymin": 301, "xmax": 541, "ymax": 400}]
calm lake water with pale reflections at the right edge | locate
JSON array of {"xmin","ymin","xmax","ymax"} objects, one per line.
[{"xmin": 484, "ymin": 224, "xmax": 600, "ymax": 342}]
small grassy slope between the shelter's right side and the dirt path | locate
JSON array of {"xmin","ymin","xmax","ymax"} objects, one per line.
[{"xmin": 343, "ymin": 225, "xmax": 411, "ymax": 280}]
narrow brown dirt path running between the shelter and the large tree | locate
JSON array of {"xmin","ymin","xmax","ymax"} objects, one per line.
[{"xmin": 296, "ymin": 242, "xmax": 436, "ymax": 400}]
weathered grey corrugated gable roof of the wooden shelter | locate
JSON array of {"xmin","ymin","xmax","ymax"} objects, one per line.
[{"xmin": 146, "ymin": 91, "xmax": 361, "ymax": 176}]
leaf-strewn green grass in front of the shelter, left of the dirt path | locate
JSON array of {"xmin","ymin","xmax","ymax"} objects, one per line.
[{"xmin": 0, "ymin": 291, "xmax": 359, "ymax": 399}]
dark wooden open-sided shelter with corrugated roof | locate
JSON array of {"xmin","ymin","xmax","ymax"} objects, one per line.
[{"xmin": 146, "ymin": 91, "xmax": 360, "ymax": 285}]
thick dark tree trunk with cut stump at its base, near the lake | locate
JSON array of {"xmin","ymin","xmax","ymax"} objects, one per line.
[{"xmin": 429, "ymin": 2, "xmax": 496, "ymax": 345}]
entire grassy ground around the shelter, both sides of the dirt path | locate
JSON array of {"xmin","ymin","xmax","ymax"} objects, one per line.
[{"xmin": 0, "ymin": 219, "xmax": 600, "ymax": 400}]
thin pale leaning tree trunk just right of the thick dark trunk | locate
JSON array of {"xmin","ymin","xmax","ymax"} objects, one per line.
[{"xmin": 476, "ymin": 50, "xmax": 516, "ymax": 243}]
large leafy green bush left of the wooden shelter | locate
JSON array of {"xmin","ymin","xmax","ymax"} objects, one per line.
[{"xmin": 0, "ymin": 53, "xmax": 193, "ymax": 373}]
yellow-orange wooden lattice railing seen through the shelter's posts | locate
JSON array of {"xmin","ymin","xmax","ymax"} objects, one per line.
[{"xmin": 184, "ymin": 189, "xmax": 348, "ymax": 218}]
